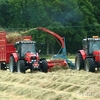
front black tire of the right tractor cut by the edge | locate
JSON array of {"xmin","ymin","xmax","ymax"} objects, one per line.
[{"xmin": 85, "ymin": 58, "xmax": 95, "ymax": 72}]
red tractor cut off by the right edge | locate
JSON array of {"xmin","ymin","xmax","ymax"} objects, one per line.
[{"xmin": 75, "ymin": 36, "xmax": 100, "ymax": 72}]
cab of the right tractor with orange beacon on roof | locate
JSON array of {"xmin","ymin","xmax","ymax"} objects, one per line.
[{"xmin": 83, "ymin": 37, "xmax": 100, "ymax": 55}]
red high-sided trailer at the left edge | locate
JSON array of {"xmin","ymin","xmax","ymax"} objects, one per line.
[{"xmin": 0, "ymin": 32, "xmax": 15, "ymax": 70}]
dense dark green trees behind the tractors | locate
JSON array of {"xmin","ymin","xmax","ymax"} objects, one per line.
[{"xmin": 0, "ymin": 0, "xmax": 100, "ymax": 54}]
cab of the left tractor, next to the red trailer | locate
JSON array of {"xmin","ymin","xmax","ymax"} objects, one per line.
[{"xmin": 15, "ymin": 41, "xmax": 36, "ymax": 59}]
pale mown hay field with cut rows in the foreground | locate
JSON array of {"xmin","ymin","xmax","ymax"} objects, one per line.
[{"xmin": 0, "ymin": 65, "xmax": 100, "ymax": 100}]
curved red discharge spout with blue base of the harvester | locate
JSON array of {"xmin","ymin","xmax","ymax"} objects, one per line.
[{"xmin": 37, "ymin": 27, "xmax": 75, "ymax": 69}]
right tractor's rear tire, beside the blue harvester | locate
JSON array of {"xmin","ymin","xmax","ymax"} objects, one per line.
[{"xmin": 75, "ymin": 53, "xmax": 84, "ymax": 71}]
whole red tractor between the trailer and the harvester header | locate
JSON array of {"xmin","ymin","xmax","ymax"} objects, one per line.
[{"xmin": 9, "ymin": 40, "xmax": 48, "ymax": 73}]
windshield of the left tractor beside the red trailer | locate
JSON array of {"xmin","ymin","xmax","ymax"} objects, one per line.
[{"xmin": 21, "ymin": 43, "xmax": 36, "ymax": 56}]
